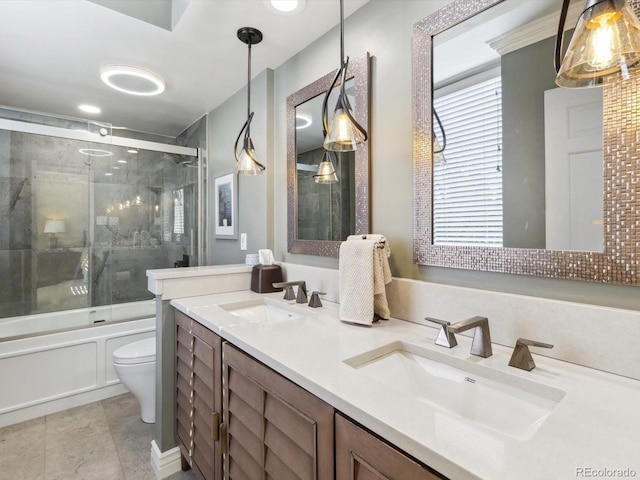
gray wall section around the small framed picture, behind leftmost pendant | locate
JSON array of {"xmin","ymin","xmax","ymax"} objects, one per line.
[{"xmin": 207, "ymin": 69, "xmax": 274, "ymax": 265}]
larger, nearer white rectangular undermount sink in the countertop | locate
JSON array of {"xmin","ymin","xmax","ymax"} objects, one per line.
[{"xmin": 344, "ymin": 341, "xmax": 565, "ymax": 440}]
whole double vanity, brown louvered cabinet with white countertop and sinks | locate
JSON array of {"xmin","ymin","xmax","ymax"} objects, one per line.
[{"xmin": 171, "ymin": 282, "xmax": 640, "ymax": 480}]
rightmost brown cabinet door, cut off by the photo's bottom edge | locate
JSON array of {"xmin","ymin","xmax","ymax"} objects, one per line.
[{"xmin": 336, "ymin": 414, "xmax": 445, "ymax": 480}]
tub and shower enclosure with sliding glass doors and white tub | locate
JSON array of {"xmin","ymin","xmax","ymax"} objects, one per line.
[{"xmin": 0, "ymin": 108, "xmax": 204, "ymax": 426}]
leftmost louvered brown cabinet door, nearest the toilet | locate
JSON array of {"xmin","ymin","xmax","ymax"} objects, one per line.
[{"xmin": 175, "ymin": 310, "xmax": 222, "ymax": 480}]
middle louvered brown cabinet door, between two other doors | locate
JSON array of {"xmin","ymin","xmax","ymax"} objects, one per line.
[{"xmin": 223, "ymin": 343, "xmax": 334, "ymax": 480}]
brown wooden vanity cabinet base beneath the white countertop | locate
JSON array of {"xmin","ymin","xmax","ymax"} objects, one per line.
[{"xmin": 175, "ymin": 310, "xmax": 446, "ymax": 480}]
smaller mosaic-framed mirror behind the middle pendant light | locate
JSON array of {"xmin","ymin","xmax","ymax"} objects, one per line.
[{"xmin": 287, "ymin": 53, "xmax": 369, "ymax": 257}]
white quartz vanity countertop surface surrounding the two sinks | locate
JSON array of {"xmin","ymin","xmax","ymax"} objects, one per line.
[{"xmin": 171, "ymin": 291, "xmax": 640, "ymax": 480}]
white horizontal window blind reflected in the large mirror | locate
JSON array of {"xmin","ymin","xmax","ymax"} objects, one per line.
[{"xmin": 433, "ymin": 75, "xmax": 502, "ymax": 246}]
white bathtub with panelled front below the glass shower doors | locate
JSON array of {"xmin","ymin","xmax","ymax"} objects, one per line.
[{"xmin": 0, "ymin": 300, "xmax": 156, "ymax": 427}]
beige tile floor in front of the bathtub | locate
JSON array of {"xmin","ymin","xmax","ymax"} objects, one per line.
[{"xmin": 0, "ymin": 394, "xmax": 195, "ymax": 480}]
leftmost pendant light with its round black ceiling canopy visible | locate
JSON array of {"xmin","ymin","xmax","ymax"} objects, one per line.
[{"xmin": 233, "ymin": 27, "xmax": 265, "ymax": 175}]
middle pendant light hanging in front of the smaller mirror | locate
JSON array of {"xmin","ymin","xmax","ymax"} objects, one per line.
[{"xmin": 322, "ymin": 0, "xmax": 367, "ymax": 152}]
